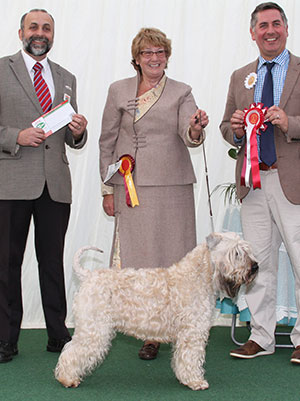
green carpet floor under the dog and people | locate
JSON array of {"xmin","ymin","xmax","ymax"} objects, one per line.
[{"xmin": 0, "ymin": 327, "xmax": 300, "ymax": 401}]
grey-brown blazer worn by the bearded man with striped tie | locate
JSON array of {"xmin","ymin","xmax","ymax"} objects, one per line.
[{"xmin": 0, "ymin": 52, "xmax": 87, "ymax": 203}]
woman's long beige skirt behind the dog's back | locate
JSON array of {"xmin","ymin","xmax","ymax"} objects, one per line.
[{"xmin": 111, "ymin": 184, "xmax": 196, "ymax": 269}]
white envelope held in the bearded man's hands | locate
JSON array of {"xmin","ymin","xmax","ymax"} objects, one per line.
[{"xmin": 32, "ymin": 99, "xmax": 76, "ymax": 137}]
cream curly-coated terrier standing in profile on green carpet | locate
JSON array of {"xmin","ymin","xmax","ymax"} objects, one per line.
[{"xmin": 55, "ymin": 233, "xmax": 258, "ymax": 390}]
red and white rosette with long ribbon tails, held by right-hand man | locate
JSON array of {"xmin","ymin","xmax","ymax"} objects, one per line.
[{"xmin": 241, "ymin": 103, "xmax": 267, "ymax": 189}]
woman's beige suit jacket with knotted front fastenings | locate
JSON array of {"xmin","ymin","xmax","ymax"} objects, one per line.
[{"xmin": 99, "ymin": 77, "xmax": 200, "ymax": 186}]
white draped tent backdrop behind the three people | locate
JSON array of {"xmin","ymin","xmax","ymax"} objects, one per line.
[{"xmin": 0, "ymin": 0, "xmax": 300, "ymax": 327}]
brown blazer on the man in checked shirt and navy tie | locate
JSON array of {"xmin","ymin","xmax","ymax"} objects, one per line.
[{"xmin": 220, "ymin": 54, "xmax": 300, "ymax": 204}]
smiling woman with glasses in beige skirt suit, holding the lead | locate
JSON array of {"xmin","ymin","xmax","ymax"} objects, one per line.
[{"xmin": 99, "ymin": 28, "xmax": 208, "ymax": 359}]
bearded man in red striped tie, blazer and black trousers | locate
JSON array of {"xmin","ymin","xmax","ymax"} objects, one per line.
[{"xmin": 0, "ymin": 9, "xmax": 87, "ymax": 363}]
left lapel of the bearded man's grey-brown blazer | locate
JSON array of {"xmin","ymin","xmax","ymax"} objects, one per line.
[{"xmin": 9, "ymin": 50, "xmax": 43, "ymax": 115}]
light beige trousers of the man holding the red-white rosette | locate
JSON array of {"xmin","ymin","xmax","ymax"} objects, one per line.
[{"xmin": 241, "ymin": 169, "xmax": 300, "ymax": 351}]
